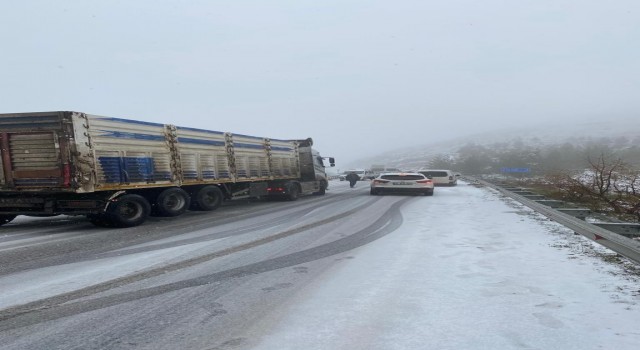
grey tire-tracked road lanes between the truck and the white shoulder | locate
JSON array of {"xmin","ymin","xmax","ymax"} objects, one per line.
[{"xmin": 0, "ymin": 182, "xmax": 412, "ymax": 349}]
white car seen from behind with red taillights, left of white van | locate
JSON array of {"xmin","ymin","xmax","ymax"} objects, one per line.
[{"xmin": 370, "ymin": 173, "xmax": 434, "ymax": 196}]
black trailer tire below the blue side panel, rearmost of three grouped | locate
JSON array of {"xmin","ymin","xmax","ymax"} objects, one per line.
[{"xmin": 107, "ymin": 194, "xmax": 151, "ymax": 227}]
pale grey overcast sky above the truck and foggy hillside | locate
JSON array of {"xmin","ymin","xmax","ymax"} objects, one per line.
[{"xmin": 0, "ymin": 0, "xmax": 640, "ymax": 166}]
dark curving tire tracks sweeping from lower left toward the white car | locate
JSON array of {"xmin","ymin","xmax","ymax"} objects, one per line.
[{"xmin": 0, "ymin": 197, "xmax": 412, "ymax": 331}]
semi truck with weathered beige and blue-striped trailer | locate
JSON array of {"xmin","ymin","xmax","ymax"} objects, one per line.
[{"xmin": 0, "ymin": 111, "xmax": 335, "ymax": 227}]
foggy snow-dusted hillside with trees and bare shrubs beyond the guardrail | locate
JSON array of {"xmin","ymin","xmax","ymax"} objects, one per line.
[{"xmin": 428, "ymin": 138, "xmax": 640, "ymax": 222}]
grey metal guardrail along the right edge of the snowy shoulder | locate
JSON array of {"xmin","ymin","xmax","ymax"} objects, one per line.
[{"xmin": 469, "ymin": 178, "xmax": 640, "ymax": 263}]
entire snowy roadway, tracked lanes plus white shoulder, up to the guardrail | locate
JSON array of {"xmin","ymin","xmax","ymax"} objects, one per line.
[{"xmin": 0, "ymin": 181, "xmax": 640, "ymax": 349}]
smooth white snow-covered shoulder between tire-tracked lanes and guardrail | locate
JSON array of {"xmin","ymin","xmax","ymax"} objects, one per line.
[{"xmin": 248, "ymin": 183, "xmax": 640, "ymax": 350}]
